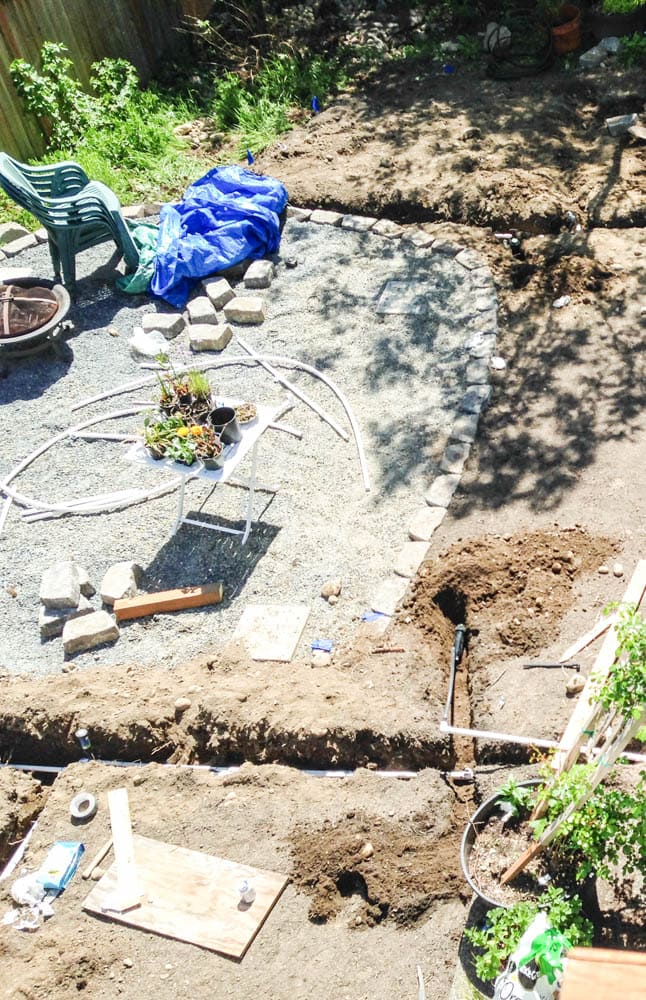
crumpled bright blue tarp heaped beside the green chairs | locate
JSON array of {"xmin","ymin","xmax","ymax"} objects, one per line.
[{"xmin": 150, "ymin": 166, "xmax": 287, "ymax": 309}]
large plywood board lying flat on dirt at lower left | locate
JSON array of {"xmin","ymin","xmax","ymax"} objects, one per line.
[{"xmin": 83, "ymin": 834, "xmax": 287, "ymax": 958}]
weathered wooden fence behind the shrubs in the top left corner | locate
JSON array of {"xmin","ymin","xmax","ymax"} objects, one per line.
[{"xmin": 0, "ymin": 0, "xmax": 211, "ymax": 159}]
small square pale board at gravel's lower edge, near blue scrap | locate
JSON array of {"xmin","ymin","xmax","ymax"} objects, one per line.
[{"xmin": 234, "ymin": 604, "xmax": 310, "ymax": 663}]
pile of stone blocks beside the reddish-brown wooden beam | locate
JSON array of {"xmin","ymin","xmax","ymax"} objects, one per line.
[{"xmin": 38, "ymin": 560, "xmax": 141, "ymax": 654}]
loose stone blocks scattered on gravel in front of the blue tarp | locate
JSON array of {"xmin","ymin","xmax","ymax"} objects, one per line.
[{"xmin": 130, "ymin": 260, "xmax": 275, "ymax": 358}]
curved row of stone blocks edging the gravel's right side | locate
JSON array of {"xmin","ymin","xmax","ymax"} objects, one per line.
[{"xmin": 287, "ymin": 205, "xmax": 498, "ymax": 633}]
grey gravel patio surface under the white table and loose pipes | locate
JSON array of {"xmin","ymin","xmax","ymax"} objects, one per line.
[{"xmin": 0, "ymin": 220, "xmax": 492, "ymax": 674}]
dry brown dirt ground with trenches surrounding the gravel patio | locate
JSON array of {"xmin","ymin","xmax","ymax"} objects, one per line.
[{"xmin": 0, "ymin": 52, "xmax": 646, "ymax": 1000}]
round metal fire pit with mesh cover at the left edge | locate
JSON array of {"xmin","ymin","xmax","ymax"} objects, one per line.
[{"xmin": 0, "ymin": 278, "xmax": 71, "ymax": 357}]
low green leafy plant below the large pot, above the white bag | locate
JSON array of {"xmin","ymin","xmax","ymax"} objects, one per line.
[{"xmin": 464, "ymin": 886, "xmax": 593, "ymax": 982}]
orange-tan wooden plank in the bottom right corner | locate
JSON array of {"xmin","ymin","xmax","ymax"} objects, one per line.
[{"xmin": 561, "ymin": 948, "xmax": 646, "ymax": 1000}]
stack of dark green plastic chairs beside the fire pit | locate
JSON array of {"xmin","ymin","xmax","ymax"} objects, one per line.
[{"xmin": 0, "ymin": 153, "xmax": 139, "ymax": 293}]
